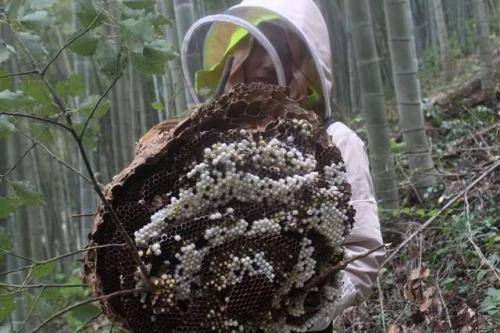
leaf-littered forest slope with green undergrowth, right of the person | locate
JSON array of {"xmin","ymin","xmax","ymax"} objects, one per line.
[{"xmin": 337, "ymin": 53, "xmax": 500, "ymax": 333}]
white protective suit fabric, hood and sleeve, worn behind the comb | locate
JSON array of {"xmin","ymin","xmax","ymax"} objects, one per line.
[{"xmin": 183, "ymin": 0, "xmax": 385, "ymax": 331}]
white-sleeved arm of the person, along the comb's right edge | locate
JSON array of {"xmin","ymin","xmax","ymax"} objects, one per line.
[{"xmin": 311, "ymin": 122, "xmax": 385, "ymax": 331}]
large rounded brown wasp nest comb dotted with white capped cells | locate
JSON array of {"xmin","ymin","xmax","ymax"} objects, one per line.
[{"xmin": 85, "ymin": 83, "xmax": 354, "ymax": 333}]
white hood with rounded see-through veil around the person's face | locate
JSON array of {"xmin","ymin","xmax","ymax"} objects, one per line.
[{"xmin": 181, "ymin": 0, "xmax": 332, "ymax": 118}]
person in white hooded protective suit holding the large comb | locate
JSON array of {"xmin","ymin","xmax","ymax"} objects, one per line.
[{"xmin": 182, "ymin": 0, "xmax": 385, "ymax": 332}]
